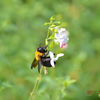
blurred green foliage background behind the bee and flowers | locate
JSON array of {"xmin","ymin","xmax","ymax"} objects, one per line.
[{"xmin": 0, "ymin": 0, "xmax": 100, "ymax": 100}]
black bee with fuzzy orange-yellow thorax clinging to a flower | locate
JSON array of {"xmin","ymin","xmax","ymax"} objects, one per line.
[{"xmin": 31, "ymin": 45, "xmax": 56, "ymax": 73}]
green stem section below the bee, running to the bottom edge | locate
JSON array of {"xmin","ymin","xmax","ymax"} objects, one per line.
[{"xmin": 29, "ymin": 66, "xmax": 43, "ymax": 100}]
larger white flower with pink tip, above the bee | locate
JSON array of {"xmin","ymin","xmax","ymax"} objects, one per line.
[{"xmin": 54, "ymin": 28, "xmax": 69, "ymax": 48}]
